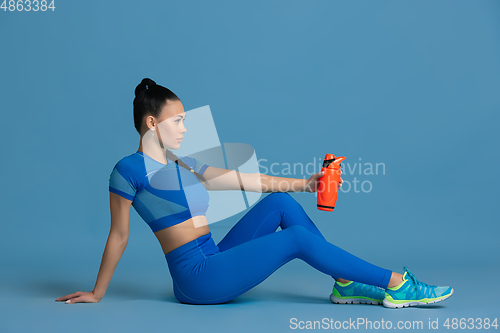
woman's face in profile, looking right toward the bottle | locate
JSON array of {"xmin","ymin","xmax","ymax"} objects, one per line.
[{"xmin": 156, "ymin": 101, "xmax": 187, "ymax": 149}]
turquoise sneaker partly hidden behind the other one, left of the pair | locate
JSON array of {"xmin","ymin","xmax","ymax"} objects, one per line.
[{"xmin": 330, "ymin": 281, "xmax": 385, "ymax": 304}]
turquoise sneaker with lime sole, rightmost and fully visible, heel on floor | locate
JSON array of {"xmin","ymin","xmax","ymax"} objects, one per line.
[{"xmin": 383, "ymin": 267, "xmax": 453, "ymax": 308}]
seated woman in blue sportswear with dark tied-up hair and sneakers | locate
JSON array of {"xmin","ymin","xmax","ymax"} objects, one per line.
[{"xmin": 56, "ymin": 78, "xmax": 453, "ymax": 308}]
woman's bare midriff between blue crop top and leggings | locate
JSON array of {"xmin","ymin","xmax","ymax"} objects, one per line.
[{"xmin": 154, "ymin": 215, "xmax": 210, "ymax": 254}]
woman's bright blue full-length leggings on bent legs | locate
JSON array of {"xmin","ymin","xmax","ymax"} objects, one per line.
[{"xmin": 165, "ymin": 192, "xmax": 392, "ymax": 304}]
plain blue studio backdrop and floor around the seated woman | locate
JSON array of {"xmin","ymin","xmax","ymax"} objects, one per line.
[{"xmin": 0, "ymin": 0, "xmax": 500, "ymax": 332}]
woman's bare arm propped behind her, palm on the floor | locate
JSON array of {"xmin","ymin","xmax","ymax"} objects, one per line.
[{"xmin": 56, "ymin": 192, "xmax": 132, "ymax": 303}]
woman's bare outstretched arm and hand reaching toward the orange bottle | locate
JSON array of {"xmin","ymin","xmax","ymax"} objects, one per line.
[{"xmin": 202, "ymin": 166, "xmax": 342, "ymax": 193}]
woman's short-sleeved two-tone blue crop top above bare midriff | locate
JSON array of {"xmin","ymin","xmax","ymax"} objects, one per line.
[{"xmin": 109, "ymin": 151, "xmax": 209, "ymax": 232}]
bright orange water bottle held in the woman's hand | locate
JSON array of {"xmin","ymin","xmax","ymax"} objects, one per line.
[{"xmin": 316, "ymin": 154, "xmax": 347, "ymax": 212}]
